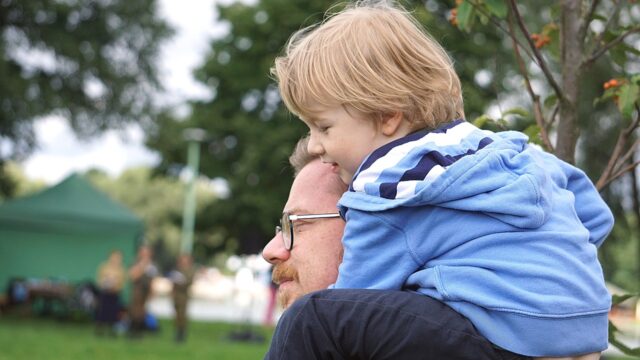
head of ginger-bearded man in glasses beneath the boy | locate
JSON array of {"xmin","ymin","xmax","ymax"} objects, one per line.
[{"xmin": 262, "ymin": 138, "xmax": 347, "ymax": 308}]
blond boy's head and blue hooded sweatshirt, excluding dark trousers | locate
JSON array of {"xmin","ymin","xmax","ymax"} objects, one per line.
[{"xmin": 272, "ymin": 4, "xmax": 613, "ymax": 358}]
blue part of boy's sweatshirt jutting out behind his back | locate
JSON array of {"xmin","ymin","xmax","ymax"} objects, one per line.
[{"xmin": 562, "ymin": 162, "xmax": 614, "ymax": 247}]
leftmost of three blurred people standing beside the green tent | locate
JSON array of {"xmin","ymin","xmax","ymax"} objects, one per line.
[{"xmin": 96, "ymin": 250, "xmax": 126, "ymax": 336}]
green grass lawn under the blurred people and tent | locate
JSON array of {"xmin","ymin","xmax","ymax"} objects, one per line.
[{"xmin": 0, "ymin": 316, "xmax": 273, "ymax": 360}]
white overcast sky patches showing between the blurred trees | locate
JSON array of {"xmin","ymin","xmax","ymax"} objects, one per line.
[{"xmin": 22, "ymin": 0, "xmax": 225, "ymax": 184}]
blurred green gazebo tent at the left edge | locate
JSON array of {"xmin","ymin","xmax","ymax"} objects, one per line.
[{"xmin": 0, "ymin": 174, "xmax": 143, "ymax": 291}]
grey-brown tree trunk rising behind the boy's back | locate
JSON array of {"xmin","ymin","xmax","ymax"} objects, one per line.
[{"xmin": 556, "ymin": 0, "xmax": 584, "ymax": 164}]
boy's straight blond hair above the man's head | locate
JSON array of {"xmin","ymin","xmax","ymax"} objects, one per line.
[{"xmin": 271, "ymin": 2, "xmax": 464, "ymax": 130}]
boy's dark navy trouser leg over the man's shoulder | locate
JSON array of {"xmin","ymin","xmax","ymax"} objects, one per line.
[{"xmin": 265, "ymin": 289, "xmax": 528, "ymax": 360}]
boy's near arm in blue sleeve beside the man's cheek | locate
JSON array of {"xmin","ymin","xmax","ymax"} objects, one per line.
[{"xmin": 331, "ymin": 209, "xmax": 420, "ymax": 290}]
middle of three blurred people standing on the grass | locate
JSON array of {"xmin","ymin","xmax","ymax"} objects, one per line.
[{"xmin": 129, "ymin": 245, "xmax": 158, "ymax": 338}]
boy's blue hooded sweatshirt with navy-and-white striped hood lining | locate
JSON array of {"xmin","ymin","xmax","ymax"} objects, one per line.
[{"xmin": 333, "ymin": 120, "xmax": 613, "ymax": 356}]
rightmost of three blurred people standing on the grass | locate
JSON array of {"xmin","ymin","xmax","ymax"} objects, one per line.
[{"xmin": 169, "ymin": 254, "xmax": 194, "ymax": 343}]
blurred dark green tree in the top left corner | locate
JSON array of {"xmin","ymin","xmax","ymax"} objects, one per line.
[{"xmin": 0, "ymin": 0, "xmax": 171, "ymax": 195}]
